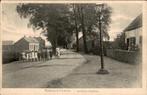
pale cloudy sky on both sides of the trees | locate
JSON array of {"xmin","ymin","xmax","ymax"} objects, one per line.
[{"xmin": 2, "ymin": 3, "xmax": 142, "ymax": 41}]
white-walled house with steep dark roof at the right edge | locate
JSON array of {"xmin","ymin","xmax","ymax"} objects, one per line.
[{"xmin": 124, "ymin": 14, "xmax": 142, "ymax": 50}]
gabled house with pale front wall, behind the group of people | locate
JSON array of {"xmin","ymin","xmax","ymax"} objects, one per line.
[{"xmin": 14, "ymin": 36, "xmax": 39, "ymax": 53}]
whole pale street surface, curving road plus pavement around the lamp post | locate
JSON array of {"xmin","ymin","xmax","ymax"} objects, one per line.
[{"xmin": 3, "ymin": 51, "xmax": 141, "ymax": 88}]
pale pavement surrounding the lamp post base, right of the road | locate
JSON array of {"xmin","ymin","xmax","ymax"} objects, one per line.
[{"xmin": 49, "ymin": 55, "xmax": 141, "ymax": 88}]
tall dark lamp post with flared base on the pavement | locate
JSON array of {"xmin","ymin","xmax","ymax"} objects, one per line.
[{"xmin": 97, "ymin": 4, "xmax": 109, "ymax": 74}]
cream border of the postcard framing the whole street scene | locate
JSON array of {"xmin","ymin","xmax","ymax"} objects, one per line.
[{"xmin": 0, "ymin": 0, "xmax": 147, "ymax": 95}]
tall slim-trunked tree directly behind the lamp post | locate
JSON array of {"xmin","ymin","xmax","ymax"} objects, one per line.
[{"xmin": 78, "ymin": 4, "xmax": 112, "ymax": 53}]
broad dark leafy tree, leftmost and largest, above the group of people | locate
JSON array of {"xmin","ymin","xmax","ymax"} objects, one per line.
[{"xmin": 17, "ymin": 4, "xmax": 73, "ymax": 53}]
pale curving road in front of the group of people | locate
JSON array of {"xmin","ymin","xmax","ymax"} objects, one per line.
[{"xmin": 3, "ymin": 51, "xmax": 86, "ymax": 88}]
